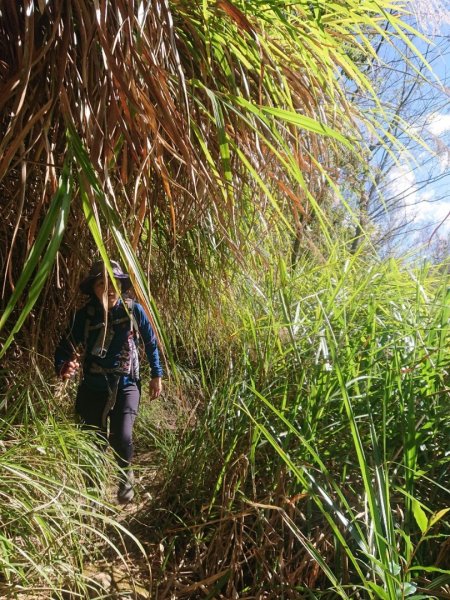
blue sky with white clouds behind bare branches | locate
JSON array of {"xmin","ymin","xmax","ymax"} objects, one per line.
[{"xmin": 382, "ymin": 11, "xmax": 450, "ymax": 251}]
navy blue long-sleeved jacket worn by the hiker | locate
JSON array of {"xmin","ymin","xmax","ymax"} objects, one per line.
[{"xmin": 55, "ymin": 298, "xmax": 163, "ymax": 390}]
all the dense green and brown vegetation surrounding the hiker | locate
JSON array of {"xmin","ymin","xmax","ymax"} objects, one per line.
[{"xmin": 0, "ymin": 0, "xmax": 450, "ymax": 600}]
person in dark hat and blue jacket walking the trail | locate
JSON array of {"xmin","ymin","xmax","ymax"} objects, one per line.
[{"xmin": 55, "ymin": 261, "xmax": 163, "ymax": 504}]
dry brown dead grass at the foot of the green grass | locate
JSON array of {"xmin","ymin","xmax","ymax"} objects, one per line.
[{"xmin": 141, "ymin": 455, "xmax": 338, "ymax": 600}]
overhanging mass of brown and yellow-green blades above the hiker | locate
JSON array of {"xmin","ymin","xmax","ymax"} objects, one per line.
[{"xmin": 0, "ymin": 0, "xmax": 422, "ymax": 354}]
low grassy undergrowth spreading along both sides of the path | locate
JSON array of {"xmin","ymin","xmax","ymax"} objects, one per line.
[{"xmin": 0, "ymin": 254, "xmax": 450, "ymax": 600}]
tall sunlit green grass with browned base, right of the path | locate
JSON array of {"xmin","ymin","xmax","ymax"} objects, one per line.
[{"xmin": 149, "ymin": 247, "xmax": 450, "ymax": 599}]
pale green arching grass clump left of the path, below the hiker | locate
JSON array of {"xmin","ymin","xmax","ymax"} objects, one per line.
[{"xmin": 0, "ymin": 368, "xmax": 149, "ymax": 598}]
